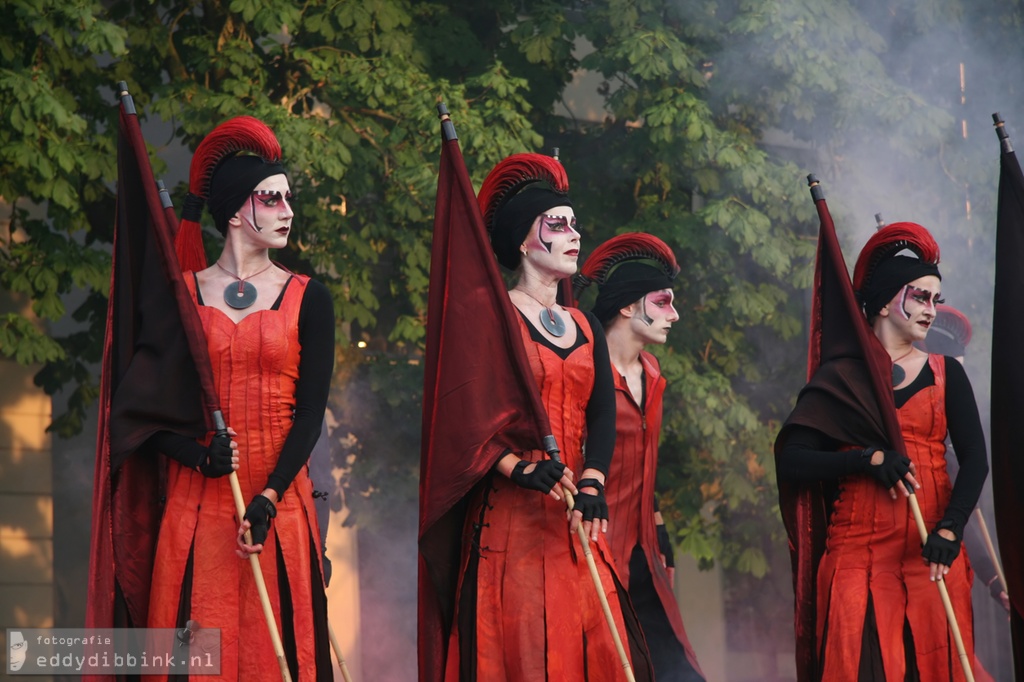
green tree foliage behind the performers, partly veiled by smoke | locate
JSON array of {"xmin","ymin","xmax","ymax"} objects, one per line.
[{"xmin": 0, "ymin": 0, "xmax": 1022, "ymax": 643}]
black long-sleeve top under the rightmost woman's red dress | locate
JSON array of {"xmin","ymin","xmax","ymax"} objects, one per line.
[{"xmin": 776, "ymin": 357, "xmax": 988, "ymax": 538}]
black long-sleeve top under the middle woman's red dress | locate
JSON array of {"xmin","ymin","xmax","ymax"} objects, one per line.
[{"xmin": 519, "ymin": 311, "xmax": 615, "ymax": 475}]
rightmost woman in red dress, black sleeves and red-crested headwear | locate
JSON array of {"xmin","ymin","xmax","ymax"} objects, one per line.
[{"xmin": 776, "ymin": 223, "xmax": 988, "ymax": 680}]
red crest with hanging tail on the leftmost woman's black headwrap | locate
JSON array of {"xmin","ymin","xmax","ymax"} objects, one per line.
[{"xmin": 174, "ymin": 116, "xmax": 281, "ymax": 270}]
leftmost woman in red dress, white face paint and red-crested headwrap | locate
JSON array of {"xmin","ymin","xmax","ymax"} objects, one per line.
[{"xmin": 147, "ymin": 117, "xmax": 334, "ymax": 680}]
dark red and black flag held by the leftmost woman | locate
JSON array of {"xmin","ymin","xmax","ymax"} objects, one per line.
[{"xmin": 86, "ymin": 84, "xmax": 215, "ymax": 643}]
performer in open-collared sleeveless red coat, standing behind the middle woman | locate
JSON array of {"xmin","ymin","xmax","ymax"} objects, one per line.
[{"xmin": 574, "ymin": 232, "xmax": 703, "ymax": 682}]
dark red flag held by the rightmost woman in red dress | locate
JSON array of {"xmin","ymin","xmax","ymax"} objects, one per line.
[{"xmin": 775, "ymin": 176, "xmax": 904, "ymax": 682}]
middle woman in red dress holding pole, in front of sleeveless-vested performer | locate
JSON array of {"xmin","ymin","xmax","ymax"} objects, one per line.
[{"xmin": 444, "ymin": 155, "xmax": 650, "ymax": 682}]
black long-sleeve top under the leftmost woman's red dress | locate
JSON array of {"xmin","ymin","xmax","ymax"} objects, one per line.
[{"xmin": 145, "ymin": 280, "xmax": 334, "ymax": 498}]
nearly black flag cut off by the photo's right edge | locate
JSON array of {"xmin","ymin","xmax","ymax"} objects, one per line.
[{"xmin": 990, "ymin": 115, "xmax": 1024, "ymax": 679}]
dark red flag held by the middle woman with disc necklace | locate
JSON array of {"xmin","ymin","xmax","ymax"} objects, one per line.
[{"xmin": 418, "ymin": 105, "xmax": 551, "ymax": 682}]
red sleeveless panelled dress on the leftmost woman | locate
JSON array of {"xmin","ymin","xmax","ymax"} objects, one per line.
[{"xmin": 148, "ymin": 273, "xmax": 324, "ymax": 682}]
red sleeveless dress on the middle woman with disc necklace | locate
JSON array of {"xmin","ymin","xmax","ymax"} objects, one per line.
[{"xmin": 444, "ymin": 309, "xmax": 628, "ymax": 682}]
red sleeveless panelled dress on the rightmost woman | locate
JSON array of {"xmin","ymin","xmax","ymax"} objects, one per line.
[{"xmin": 817, "ymin": 355, "xmax": 974, "ymax": 682}]
